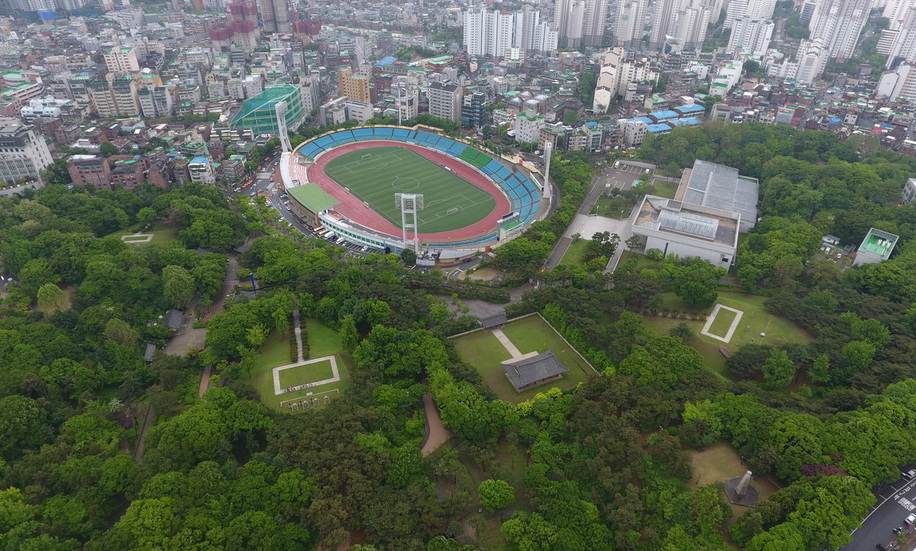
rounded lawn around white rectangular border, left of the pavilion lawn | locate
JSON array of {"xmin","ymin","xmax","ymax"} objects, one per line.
[{"xmin": 249, "ymin": 320, "xmax": 351, "ymax": 411}]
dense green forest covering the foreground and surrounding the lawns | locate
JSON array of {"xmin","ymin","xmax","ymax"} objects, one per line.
[{"xmin": 0, "ymin": 125, "xmax": 916, "ymax": 551}]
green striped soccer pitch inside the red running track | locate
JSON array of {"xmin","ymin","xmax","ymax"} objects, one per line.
[{"xmin": 325, "ymin": 147, "xmax": 496, "ymax": 233}]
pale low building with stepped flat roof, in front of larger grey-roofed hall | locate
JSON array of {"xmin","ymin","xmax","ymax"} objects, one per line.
[{"xmin": 632, "ymin": 195, "xmax": 741, "ymax": 270}]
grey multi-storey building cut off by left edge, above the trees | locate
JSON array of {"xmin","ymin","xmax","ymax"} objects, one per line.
[{"xmin": 0, "ymin": 119, "xmax": 54, "ymax": 188}]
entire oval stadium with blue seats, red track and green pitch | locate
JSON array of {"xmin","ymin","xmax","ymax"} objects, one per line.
[{"xmin": 281, "ymin": 126, "xmax": 551, "ymax": 264}]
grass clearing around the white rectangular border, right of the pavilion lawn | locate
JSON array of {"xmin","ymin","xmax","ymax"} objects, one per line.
[{"xmin": 643, "ymin": 291, "xmax": 811, "ymax": 376}]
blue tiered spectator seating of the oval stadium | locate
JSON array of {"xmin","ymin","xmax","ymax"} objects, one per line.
[{"xmin": 299, "ymin": 126, "xmax": 541, "ymax": 224}]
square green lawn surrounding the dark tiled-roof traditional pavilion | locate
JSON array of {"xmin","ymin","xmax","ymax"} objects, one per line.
[{"xmin": 452, "ymin": 316, "xmax": 594, "ymax": 402}]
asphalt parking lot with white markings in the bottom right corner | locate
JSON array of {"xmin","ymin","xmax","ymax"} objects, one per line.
[{"xmin": 843, "ymin": 466, "xmax": 916, "ymax": 551}]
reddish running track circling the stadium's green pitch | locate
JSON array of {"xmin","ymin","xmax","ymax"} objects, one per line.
[{"xmin": 306, "ymin": 140, "xmax": 512, "ymax": 243}]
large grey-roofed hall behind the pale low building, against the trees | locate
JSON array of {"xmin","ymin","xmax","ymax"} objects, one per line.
[{"xmin": 674, "ymin": 159, "xmax": 759, "ymax": 232}]
